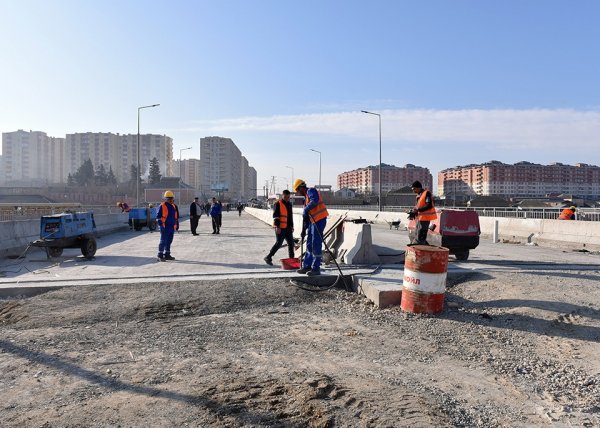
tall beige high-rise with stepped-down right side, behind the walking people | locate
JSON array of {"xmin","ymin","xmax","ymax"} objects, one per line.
[{"xmin": 200, "ymin": 137, "xmax": 256, "ymax": 200}]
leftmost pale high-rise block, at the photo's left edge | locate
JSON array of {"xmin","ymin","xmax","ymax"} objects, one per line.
[{"xmin": 0, "ymin": 129, "xmax": 66, "ymax": 186}]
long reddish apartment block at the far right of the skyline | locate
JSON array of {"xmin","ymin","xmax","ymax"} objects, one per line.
[{"xmin": 438, "ymin": 161, "xmax": 600, "ymax": 199}]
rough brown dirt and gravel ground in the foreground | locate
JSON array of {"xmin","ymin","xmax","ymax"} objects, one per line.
[{"xmin": 0, "ymin": 264, "xmax": 600, "ymax": 427}]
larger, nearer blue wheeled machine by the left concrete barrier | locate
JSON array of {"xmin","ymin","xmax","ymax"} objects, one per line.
[{"xmin": 31, "ymin": 212, "xmax": 97, "ymax": 259}]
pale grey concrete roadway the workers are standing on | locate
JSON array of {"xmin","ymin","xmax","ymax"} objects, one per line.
[{"xmin": 0, "ymin": 211, "xmax": 600, "ymax": 300}]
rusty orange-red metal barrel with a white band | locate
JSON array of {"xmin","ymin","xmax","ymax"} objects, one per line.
[{"xmin": 400, "ymin": 245, "xmax": 449, "ymax": 314}]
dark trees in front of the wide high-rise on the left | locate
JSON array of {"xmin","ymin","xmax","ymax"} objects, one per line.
[{"xmin": 67, "ymin": 157, "xmax": 162, "ymax": 187}]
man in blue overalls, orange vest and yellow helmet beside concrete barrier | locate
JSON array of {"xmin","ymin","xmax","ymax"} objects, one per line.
[{"xmin": 293, "ymin": 178, "xmax": 329, "ymax": 276}]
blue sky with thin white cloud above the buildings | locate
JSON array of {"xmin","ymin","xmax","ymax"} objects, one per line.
[{"xmin": 0, "ymin": 0, "xmax": 600, "ymax": 194}]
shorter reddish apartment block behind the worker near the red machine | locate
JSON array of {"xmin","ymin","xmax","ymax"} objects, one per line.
[{"xmin": 337, "ymin": 164, "xmax": 433, "ymax": 194}]
